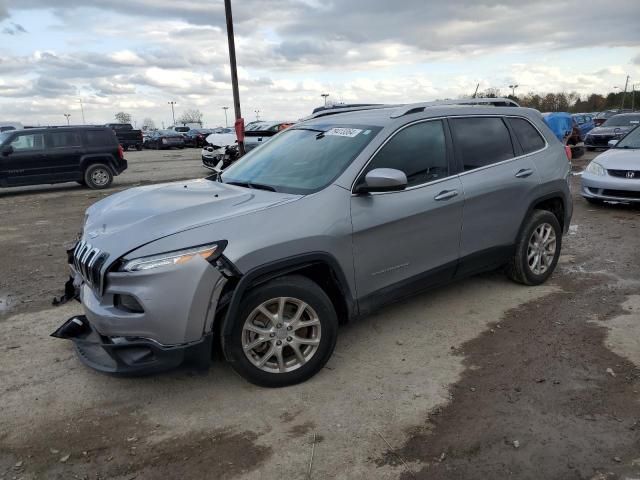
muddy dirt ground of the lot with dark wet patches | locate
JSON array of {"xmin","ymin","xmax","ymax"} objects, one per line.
[{"xmin": 0, "ymin": 150, "xmax": 640, "ymax": 480}]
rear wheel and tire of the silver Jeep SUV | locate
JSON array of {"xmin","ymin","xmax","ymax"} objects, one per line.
[{"xmin": 507, "ymin": 210, "xmax": 562, "ymax": 285}]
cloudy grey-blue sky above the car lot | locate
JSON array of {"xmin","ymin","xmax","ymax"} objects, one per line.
[{"xmin": 0, "ymin": 0, "xmax": 640, "ymax": 126}]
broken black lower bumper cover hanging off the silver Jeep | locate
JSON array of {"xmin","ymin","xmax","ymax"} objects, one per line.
[{"xmin": 51, "ymin": 315, "xmax": 211, "ymax": 375}]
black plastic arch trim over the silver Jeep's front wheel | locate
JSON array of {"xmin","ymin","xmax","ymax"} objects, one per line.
[{"xmin": 221, "ymin": 252, "xmax": 357, "ymax": 337}]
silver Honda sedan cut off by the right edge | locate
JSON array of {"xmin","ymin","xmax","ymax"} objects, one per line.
[{"xmin": 581, "ymin": 127, "xmax": 640, "ymax": 203}]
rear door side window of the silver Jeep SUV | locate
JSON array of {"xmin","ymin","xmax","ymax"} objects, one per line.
[{"xmin": 450, "ymin": 117, "xmax": 514, "ymax": 171}]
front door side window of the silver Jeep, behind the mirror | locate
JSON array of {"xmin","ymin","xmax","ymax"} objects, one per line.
[{"xmin": 365, "ymin": 120, "xmax": 449, "ymax": 187}]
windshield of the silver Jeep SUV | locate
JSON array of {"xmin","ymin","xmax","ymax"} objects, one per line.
[{"xmin": 221, "ymin": 125, "xmax": 381, "ymax": 194}]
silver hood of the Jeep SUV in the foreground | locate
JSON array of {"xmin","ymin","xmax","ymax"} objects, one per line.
[{"xmin": 83, "ymin": 179, "xmax": 300, "ymax": 260}]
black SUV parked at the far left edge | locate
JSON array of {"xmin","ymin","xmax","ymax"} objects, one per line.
[{"xmin": 0, "ymin": 127, "xmax": 127, "ymax": 189}]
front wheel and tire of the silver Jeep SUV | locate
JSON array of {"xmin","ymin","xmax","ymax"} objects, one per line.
[{"xmin": 222, "ymin": 275, "xmax": 338, "ymax": 388}]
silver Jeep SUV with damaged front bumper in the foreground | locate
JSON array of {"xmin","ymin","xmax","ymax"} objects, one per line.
[{"xmin": 53, "ymin": 99, "xmax": 572, "ymax": 387}]
